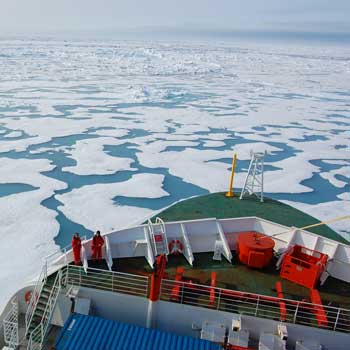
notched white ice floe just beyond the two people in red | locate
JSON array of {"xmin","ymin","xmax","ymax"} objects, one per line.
[{"xmin": 56, "ymin": 174, "xmax": 168, "ymax": 232}]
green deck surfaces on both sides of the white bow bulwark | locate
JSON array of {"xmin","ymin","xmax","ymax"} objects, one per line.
[{"xmin": 114, "ymin": 193, "xmax": 350, "ymax": 309}]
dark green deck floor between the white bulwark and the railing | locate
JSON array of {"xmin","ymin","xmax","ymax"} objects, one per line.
[{"xmin": 96, "ymin": 252, "xmax": 350, "ymax": 309}]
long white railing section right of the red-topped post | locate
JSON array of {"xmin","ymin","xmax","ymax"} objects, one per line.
[{"xmin": 160, "ymin": 279, "xmax": 350, "ymax": 333}]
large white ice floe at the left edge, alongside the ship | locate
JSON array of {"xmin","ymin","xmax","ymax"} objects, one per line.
[{"xmin": 0, "ymin": 158, "xmax": 67, "ymax": 310}]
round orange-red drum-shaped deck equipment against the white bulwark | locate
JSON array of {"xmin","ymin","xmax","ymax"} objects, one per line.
[{"xmin": 238, "ymin": 231, "xmax": 275, "ymax": 269}]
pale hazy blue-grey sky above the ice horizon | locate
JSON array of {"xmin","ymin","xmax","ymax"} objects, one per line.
[{"xmin": 0, "ymin": 0, "xmax": 350, "ymax": 34}]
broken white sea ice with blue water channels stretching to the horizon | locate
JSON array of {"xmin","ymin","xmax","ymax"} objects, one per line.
[{"xmin": 0, "ymin": 39, "xmax": 350, "ymax": 312}]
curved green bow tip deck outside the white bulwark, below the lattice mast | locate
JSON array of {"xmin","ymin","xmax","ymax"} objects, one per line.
[{"xmin": 153, "ymin": 193, "xmax": 349, "ymax": 244}]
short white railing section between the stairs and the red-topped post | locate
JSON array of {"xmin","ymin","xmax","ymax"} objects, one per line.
[{"xmin": 62, "ymin": 265, "xmax": 148, "ymax": 298}]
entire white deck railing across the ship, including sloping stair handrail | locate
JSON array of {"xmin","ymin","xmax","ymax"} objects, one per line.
[{"xmin": 23, "ymin": 265, "xmax": 350, "ymax": 349}]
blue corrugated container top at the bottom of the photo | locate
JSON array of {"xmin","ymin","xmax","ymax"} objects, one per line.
[{"xmin": 55, "ymin": 314, "xmax": 222, "ymax": 350}]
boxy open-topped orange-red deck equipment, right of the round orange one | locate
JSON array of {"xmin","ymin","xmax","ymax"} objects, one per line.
[{"xmin": 280, "ymin": 245, "xmax": 328, "ymax": 289}]
